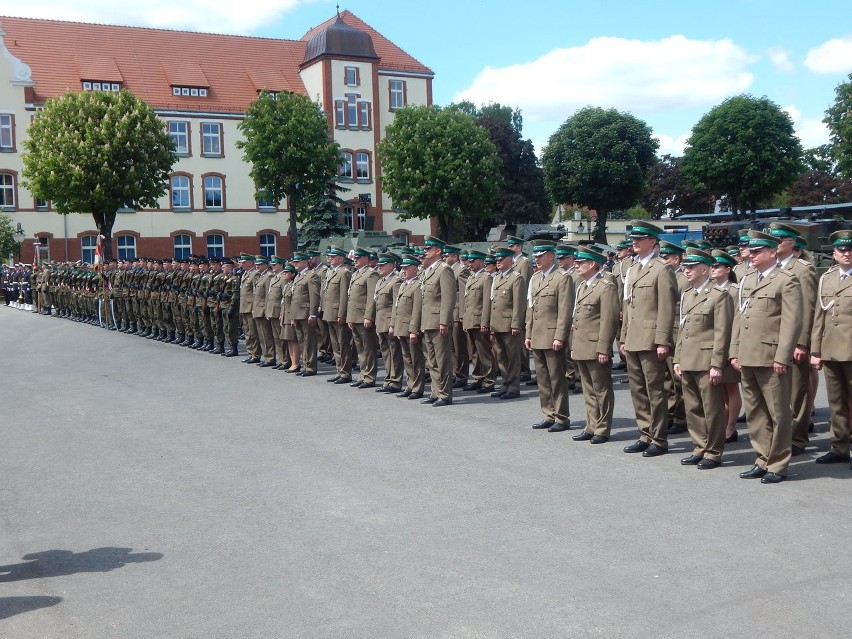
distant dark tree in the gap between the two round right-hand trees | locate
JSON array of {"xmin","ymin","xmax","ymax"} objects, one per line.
[{"xmin": 642, "ymin": 154, "xmax": 712, "ymax": 220}]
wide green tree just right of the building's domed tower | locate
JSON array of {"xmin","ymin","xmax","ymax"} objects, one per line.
[{"xmin": 379, "ymin": 106, "xmax": 502, "ymax": 241}]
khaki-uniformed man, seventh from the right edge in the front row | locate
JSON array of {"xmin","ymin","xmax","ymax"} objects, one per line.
[{"xmin": 483, "ymin": 248, "xmax": 527, "ymax": 399}]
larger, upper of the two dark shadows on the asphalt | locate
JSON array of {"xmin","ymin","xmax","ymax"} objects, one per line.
[{"xmin": 0, "ymin": 547, "xmax": 163, "ymax": 584}]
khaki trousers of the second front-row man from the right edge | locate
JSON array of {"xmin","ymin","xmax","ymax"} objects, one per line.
[{"xmin": 742, "ymin": 366, "xmax": 793, "ymax": 475}]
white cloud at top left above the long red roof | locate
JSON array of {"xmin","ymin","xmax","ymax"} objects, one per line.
[{"xmin": 2, "ymin": 0, "xmax": 317, "ymax": 34}]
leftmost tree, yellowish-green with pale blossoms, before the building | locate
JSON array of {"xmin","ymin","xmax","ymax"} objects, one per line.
[{"xmin": 22, "ymin": 90, "xmax": 176, "ymax": 258}]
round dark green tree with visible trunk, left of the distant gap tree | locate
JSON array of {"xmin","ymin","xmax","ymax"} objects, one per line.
[{"xmin": 541, "ymin": 107, "xmax": 659, "ymax": 242}]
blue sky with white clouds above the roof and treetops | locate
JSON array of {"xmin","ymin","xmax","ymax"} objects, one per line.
[{"xmin": 0, "ymin": 0, "xmax": 852, "ymax": 155}]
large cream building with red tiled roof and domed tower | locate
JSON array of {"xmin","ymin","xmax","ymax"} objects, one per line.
[{"xmin": 0, "ymin": 11, "xmax": 434, "ymax": 262}]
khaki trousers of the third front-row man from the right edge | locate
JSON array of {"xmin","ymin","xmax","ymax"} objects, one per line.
[{"xmin": 681, "ymin": 371, "xmax": 728, "ymax": 461}]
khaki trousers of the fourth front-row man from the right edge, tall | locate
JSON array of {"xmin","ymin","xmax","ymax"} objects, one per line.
[{"xmin": 627, "ymin": 350, "xmax": 669, "ymax": 448}]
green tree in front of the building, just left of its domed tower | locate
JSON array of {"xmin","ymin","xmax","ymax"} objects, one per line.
[{"xmin": 237, "ymin": 91, "xmax": 340, "ymax": 248}]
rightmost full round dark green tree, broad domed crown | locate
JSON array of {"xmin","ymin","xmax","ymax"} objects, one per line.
[{"xmin": 682, "ymin": 95, "xmax": 802, "ymax": 214}]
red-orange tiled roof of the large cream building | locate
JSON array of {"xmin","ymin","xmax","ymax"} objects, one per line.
[{"xmin": 0, "ymin": 11, "xmax": 431, "ymax": 113}]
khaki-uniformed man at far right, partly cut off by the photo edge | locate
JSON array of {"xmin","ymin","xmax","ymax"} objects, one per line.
[{"xmin": 810, "ymin": 231, "xmax": 852, "ymax": 464}]
